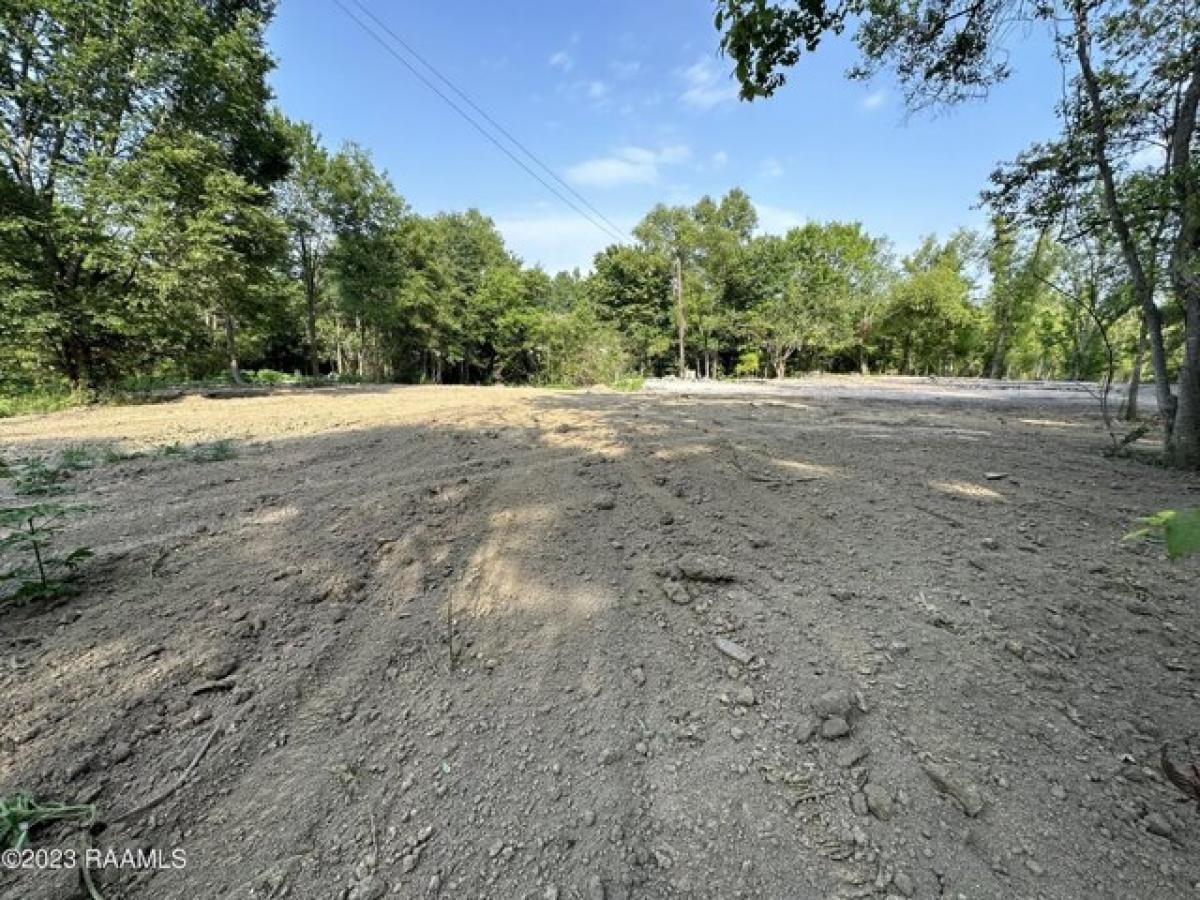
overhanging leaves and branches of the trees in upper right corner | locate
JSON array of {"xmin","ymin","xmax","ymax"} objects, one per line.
[{"xmin": 716, "ymin": 0, "xmax": 1200, "ymax": 469}]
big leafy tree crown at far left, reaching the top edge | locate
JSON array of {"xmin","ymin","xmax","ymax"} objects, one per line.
[{"xmin": 0, "ymin": 0, "xmax": 286, "ymax": 388}]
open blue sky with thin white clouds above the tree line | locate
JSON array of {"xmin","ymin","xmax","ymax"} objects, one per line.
[{"xmin": 269, "ymin": 0, "xmax": 1061, "ymax": 271}]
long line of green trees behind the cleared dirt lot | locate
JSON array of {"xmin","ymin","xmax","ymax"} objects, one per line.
[{"xmin": 0, "ymin": 0, "xmax": 1196, "ymax": 472}]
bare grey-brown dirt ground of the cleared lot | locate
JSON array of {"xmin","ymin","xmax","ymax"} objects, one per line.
[{"xmin": 0, "ymin": 382, "xmax": 1200, "ymax": 900}]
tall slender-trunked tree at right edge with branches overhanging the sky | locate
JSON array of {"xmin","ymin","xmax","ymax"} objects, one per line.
[{"xmin": 716, "ymin": 0, "xmax": 1200, "ymax": 469}]
